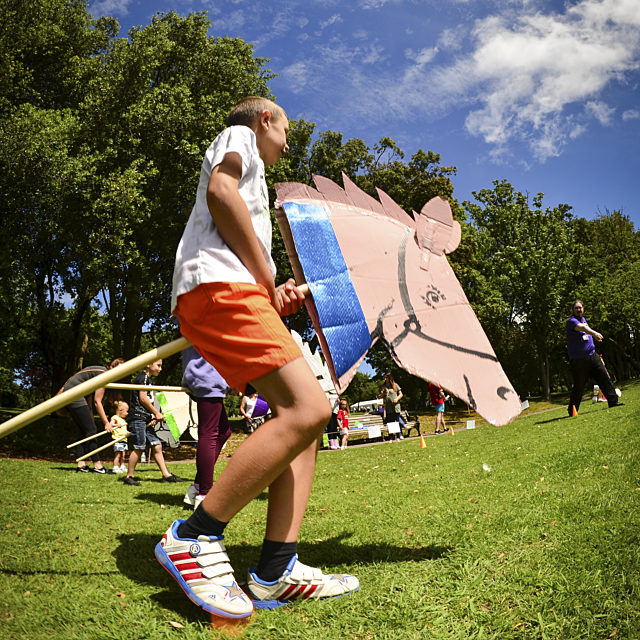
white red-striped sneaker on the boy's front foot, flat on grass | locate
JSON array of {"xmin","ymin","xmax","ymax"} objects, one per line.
[{"xmin": 247, "ymin": 555, "xmax": 360, "ymax": 609}]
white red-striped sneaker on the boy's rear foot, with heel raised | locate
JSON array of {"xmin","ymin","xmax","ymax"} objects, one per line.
[{"xmin": 155, "ymin": 520, "xmax": 253, "ymax": 618}]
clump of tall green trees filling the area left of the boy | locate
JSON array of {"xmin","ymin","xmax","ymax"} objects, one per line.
[{"xmin": 0, "ymin": 6, "xmax": 280, "ymax": 390}]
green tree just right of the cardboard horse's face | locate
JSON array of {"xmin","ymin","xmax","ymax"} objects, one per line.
[{"xmin": 463, "ymin": 180, "xmax": 575, "ymax": 398}]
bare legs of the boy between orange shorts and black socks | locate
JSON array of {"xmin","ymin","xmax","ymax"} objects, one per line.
[{"xmin": 202, "ymin": 358, "xmax": 331, "ymax": 528}]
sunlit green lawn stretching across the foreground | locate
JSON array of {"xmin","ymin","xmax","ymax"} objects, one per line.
[{"xmin": 0, "ymin": 384, "xmax": 640, "ymax": 640}]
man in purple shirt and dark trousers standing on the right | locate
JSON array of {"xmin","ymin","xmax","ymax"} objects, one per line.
[{"xmin": 567, "ymin": 300, "xmax": 624, "ymax": 416}]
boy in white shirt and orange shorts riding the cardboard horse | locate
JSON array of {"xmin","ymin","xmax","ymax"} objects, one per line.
[{"xmin": 156, "ymin": 97, "xmax": 359, "ymax": 618}]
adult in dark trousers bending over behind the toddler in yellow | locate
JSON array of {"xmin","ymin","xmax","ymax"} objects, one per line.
[{"xmin": 58, "ymin": 358, "xmax": 124, "ymax": 475}]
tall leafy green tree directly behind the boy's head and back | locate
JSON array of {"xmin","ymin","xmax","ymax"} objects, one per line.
[{"xmin": 81, "ymin": 12, "xmax": 272, "ymax": 357}]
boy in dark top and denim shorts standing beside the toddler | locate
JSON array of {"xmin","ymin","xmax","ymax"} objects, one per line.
[{"xmin": 124, "ymin": 360, "xmax": 183, "ymax": 487}]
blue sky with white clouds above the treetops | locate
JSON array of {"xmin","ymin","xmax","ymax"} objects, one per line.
[{"xmin": 90, "ymin": 0, "xmax": 640, "ymax": 229}]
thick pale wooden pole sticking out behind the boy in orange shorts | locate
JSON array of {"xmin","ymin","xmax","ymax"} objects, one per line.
[{"xmin": 0, "ymin": 338, "xmax": 191, "ymax": 438}]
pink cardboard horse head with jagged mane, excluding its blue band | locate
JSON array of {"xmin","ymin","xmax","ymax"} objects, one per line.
[{"xmin": 276, "ymin": 175, "xmax": 520, "ymax": 425}]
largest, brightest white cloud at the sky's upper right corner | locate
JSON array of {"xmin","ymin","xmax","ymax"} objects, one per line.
[{"xmin": 437, "ymin": 0, "xmax": 640, "ymax": 161}]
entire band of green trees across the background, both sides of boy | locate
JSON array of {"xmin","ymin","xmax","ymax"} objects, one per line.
[{"xmin": 0, "ymin": 0, "xmax": 640, "ymax": 406}]
